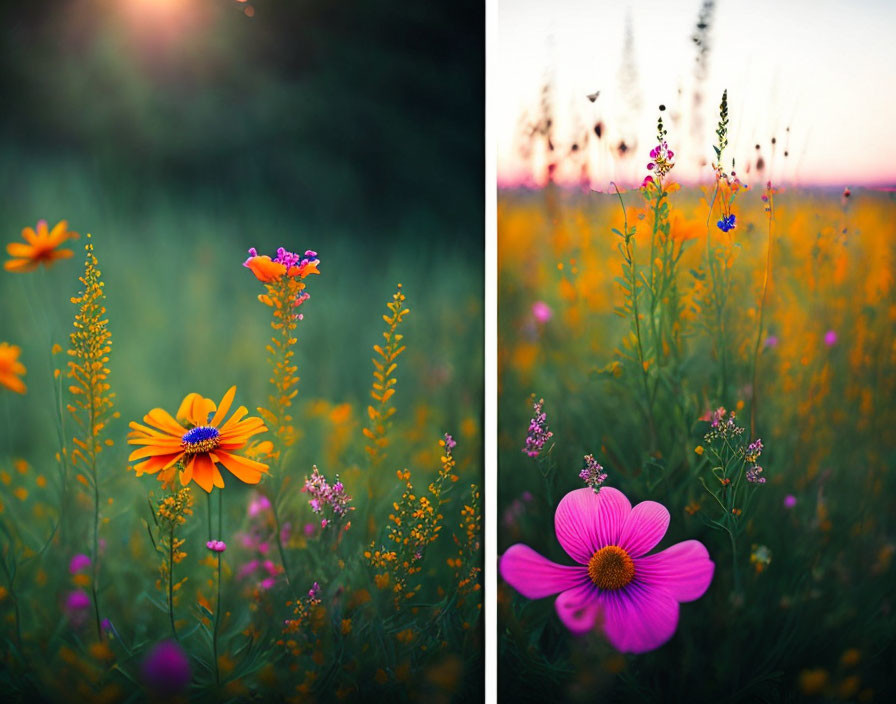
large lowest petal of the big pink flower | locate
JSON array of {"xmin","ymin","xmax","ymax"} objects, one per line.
[{"xmin": 600, "ymin": 581, "xmax": 678, "ymax": 653}]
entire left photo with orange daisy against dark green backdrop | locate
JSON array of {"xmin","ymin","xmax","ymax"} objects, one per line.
[{"xmin": 0, "ymin": 0, "xmax": 485, "ymax": 703}]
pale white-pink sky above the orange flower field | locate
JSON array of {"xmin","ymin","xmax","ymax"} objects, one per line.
[{"xmin": 493, "ymin": 0, "xmax": 896, "ymax": 187}]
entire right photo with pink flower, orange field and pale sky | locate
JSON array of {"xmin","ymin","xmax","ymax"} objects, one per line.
[{"xmin": 491, "ymin": 0, "xmax": 896, "ymax": 702}]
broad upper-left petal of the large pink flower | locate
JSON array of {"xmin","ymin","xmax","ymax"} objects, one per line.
[{"xmin": 554, "ymin": 486, "xmax": 632, "ymax": 565}]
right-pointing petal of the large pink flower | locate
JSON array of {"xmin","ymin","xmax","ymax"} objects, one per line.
[{"xmin": 635, "ymin": 540, "xmax": 715, "ymax": 601}]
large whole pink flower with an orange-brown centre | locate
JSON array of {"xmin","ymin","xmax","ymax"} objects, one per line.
[{"xmin": 499, "ymin": 487, "xmax": 715, "ymax": 653}]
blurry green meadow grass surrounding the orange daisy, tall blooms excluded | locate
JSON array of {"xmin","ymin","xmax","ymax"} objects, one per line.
[{"xmin": 0, "ymin": 151, "xmax": 483, "ymax": 701}]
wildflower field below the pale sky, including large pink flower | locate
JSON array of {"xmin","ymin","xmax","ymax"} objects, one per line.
[{"xmin": 498, "ymin": 102, "xmax": 896, "ymax": 702}]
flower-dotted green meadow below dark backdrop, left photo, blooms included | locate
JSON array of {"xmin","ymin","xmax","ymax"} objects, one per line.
[{"xmin": 0, "ymin": 176, "xmax": 483, "ymax": 702}]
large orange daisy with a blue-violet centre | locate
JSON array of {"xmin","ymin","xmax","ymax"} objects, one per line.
[{"xmin": 128, "ymin": 386, "xmax": 268, "ymax": 493}]
